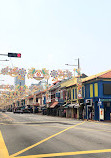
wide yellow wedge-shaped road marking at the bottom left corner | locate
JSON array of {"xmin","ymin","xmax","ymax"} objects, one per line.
[{"xmin": 0, "ymin": 131, "xmax": 9, "ymax": 158}]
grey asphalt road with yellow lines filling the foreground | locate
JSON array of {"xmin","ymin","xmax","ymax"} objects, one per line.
[{"xmin": 0, "ymin": 112, "xmax": 111, "ymax": 158}]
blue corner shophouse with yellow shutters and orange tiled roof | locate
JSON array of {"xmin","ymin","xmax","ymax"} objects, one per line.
[{"xmin": 82, "ymin": 70, "xmax": 111, "ymax": 121}]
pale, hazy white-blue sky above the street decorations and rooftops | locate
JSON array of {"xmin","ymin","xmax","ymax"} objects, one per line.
[{"xmin": 0, "ymin": 0, "xmax": 111, "ymax": 84}]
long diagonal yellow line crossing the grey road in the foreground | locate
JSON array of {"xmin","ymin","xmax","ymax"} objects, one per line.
[{"xmin": 11, "ymin": 122, "xmax": 84, "ymax": 157}]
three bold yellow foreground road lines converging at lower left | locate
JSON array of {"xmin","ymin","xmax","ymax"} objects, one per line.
[{"xmin": 0, "ymin": 122, "xmax": 111, "ymax": 158}]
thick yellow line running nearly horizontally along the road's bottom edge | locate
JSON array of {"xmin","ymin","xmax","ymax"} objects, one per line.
[{"xmin": 12, "ymin": 149, "xmax": 111, "ymax": 158}]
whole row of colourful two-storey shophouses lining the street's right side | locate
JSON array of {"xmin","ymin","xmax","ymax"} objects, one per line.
[{"xmin": 9, "ymin": 70, "xmax": 111, "ymax": 120}]
